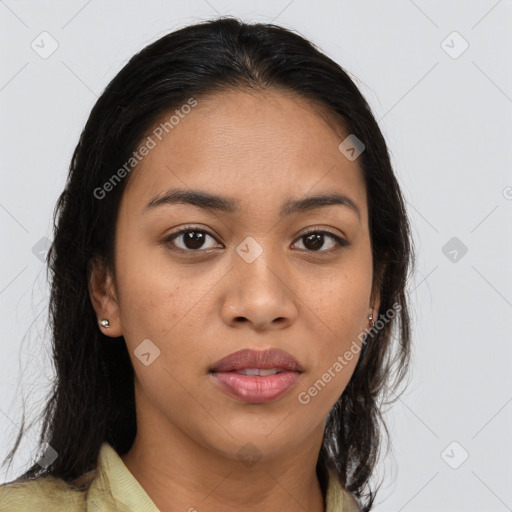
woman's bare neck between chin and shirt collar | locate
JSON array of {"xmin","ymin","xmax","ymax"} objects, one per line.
[{"xmin": 122, "ymin": 418, "xmax": 325, "ymax": 512}]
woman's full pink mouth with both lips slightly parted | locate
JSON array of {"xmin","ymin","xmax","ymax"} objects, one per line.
[{"xmin": 210, "ymin": 349, "xmax": 303, "ymax": 404}]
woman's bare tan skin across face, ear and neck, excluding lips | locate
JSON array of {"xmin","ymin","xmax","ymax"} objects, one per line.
[{"xmin": 90, "ymin": 90, "xmax": 379, "ymax": 512}]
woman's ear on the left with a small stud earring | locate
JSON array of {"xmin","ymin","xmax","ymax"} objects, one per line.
[{"xmin": 88, "ymin": 257, "xmax": 123, "ymax": 338}]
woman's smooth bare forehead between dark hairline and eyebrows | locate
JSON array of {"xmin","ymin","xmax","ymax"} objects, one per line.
[{"xmin": 125, "ymin": 90, "xmax": 366, "ymax": 222}]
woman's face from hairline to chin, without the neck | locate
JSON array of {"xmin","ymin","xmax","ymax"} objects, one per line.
[{"xmin": 93, "ymin": 91, "xmax": 378, "ymax": 458}]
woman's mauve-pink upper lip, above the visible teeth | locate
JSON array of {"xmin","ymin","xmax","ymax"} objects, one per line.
[{"xmin": 210, "ymin": 348, "xmax": 303, "ymax": 372}]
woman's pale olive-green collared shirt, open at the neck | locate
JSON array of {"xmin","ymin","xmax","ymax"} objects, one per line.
[{"xmin": 0, "ymin": 442, "xmax": 359, "ymax": 512}]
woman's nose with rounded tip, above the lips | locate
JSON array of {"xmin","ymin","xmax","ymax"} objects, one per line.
[{"xmin": 221, "ymin": 244, "xmax": 299, "ymax": 331}]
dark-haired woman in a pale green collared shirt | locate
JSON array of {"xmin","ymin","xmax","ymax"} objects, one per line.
[{"xmin": 0, "ymin": 18, "xmax": 412, "ymax": 512}]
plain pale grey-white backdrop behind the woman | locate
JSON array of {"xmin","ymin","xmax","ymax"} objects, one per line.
[{"xmin": 0, "ymin": 0, "xmax": 512, "ymax": 512}]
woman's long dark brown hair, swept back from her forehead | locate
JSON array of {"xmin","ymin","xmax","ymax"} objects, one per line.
[{"xmin": 4, "ymin": 17, "xmax": 413, "ymax": 511}]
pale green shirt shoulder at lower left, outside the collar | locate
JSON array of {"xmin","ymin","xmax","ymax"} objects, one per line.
[{"xmin": 0, "ymin": 476, "xmax": 86, "ymax": 512}]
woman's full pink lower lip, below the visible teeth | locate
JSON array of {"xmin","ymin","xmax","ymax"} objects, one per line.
[{"xmin": 211, "ymin": 372, "xmax": 300, "ymax": 404}]
